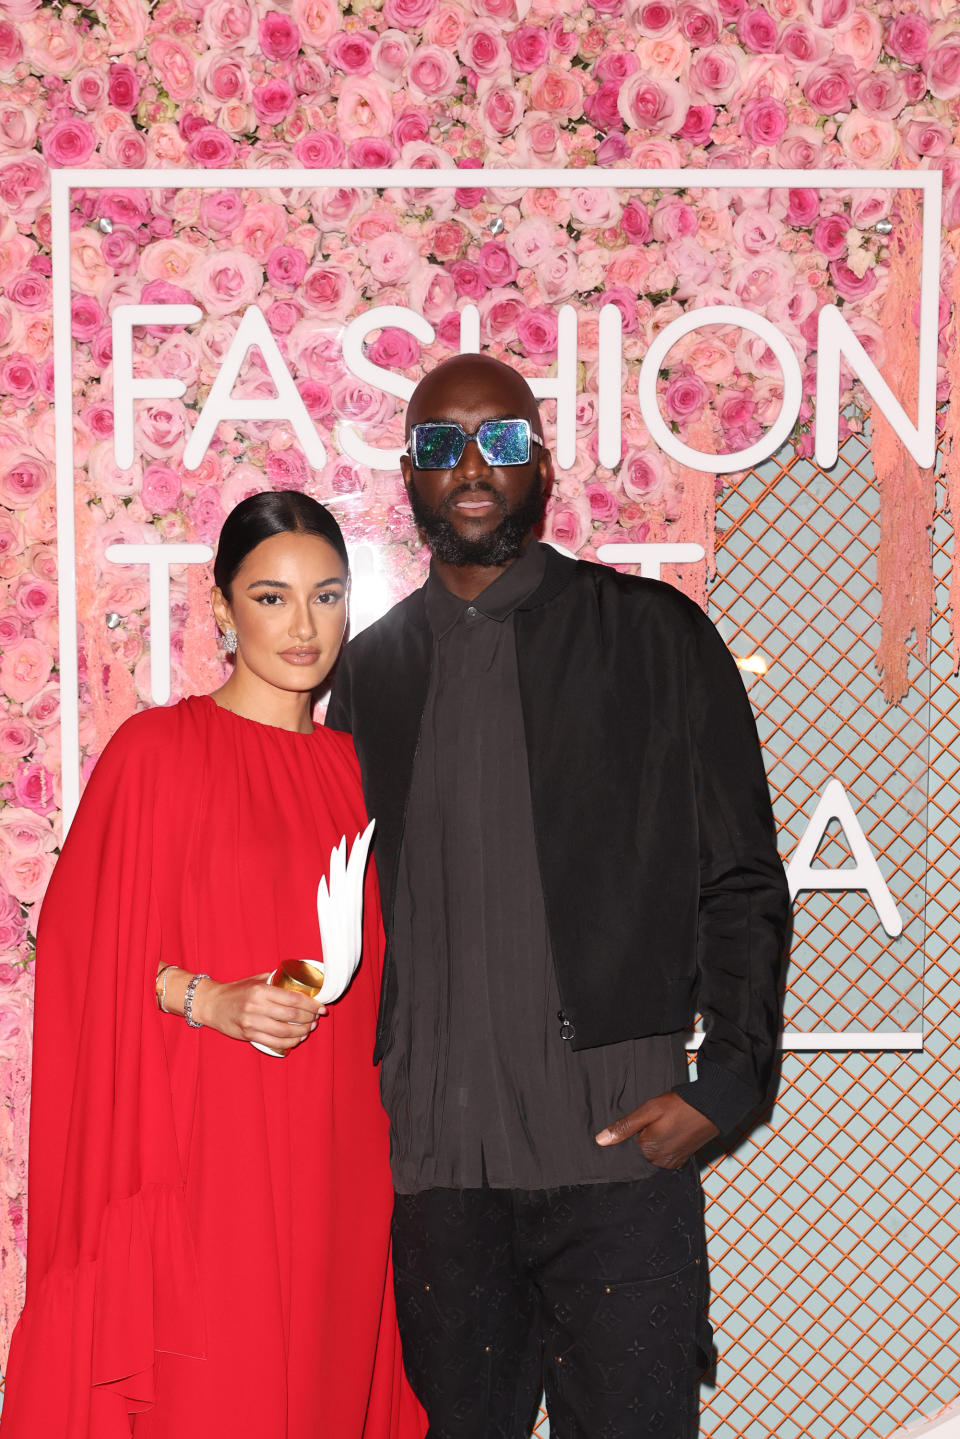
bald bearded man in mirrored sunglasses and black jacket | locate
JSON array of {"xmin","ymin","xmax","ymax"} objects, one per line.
[{"xmin": 327, "ymin": 355, "xmax": 789, "ymax": 1439}]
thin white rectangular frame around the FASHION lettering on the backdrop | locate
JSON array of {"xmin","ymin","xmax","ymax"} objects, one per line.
[{"xmin": 50, "ymin": 168, "xmax": 943, "ymax": 1052}]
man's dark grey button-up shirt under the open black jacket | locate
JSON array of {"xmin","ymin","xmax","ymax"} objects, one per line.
[{"xmin": 381, "ymin": 544, "xmax": 687, "ymax": 1193}]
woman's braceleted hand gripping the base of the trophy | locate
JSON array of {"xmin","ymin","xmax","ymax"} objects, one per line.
[{"xmin": 170, "ymin": 970, "xmax": 327, "ymax": 1050}]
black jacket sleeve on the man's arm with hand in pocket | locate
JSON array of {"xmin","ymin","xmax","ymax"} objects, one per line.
[{"xmin": 675, "ymin": 616, "xmax": 790, "ymax": 1132}]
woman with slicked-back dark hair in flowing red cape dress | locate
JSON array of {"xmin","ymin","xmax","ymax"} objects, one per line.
[{"xmin": 3, "ymin": 492, "xmax": 426, "ymax": 1439}]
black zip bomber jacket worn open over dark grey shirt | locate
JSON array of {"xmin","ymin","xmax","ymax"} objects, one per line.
[{"xmin": 327, "ymin": 547, "xmax": 790, "ymax": 1131}]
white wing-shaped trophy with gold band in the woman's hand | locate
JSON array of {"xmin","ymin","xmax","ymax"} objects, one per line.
[{"xmin": 253, "ymin": 820, "xmax": 376, "ymax": 1059}]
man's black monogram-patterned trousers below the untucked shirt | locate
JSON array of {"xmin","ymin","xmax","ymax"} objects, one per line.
[{"xmin": 393, "ymin": 1161, "xmax": 711, "ymax": 1439}]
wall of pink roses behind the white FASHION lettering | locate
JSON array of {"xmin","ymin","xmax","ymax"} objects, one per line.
[{"xmin": 0, "ymin": 0, "xmax": 960, "ymax": 1363}]
